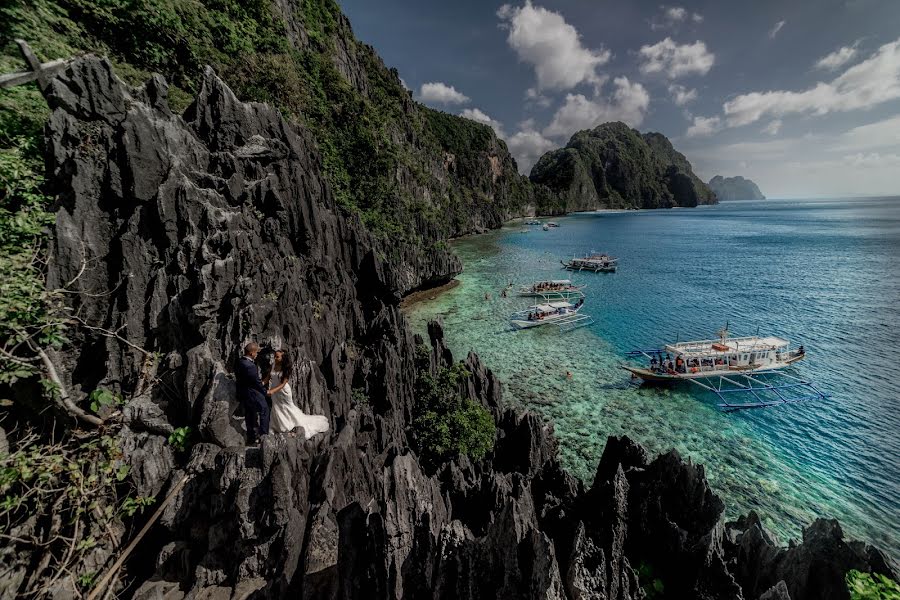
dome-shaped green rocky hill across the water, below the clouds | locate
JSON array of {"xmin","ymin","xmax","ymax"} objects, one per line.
[{"xmin": 531, "ymin": 122, "xmax": 715, "ymax": 212}]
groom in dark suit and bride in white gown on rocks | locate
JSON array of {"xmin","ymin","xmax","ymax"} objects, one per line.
[{"xmin": 235, "ymin": 342, "xmax": 328, "ymax": 444}]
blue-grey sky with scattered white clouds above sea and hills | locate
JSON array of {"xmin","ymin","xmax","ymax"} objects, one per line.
[{"xmin": 339, "ymin": 0, "xmax": 900, "ymax": 198}]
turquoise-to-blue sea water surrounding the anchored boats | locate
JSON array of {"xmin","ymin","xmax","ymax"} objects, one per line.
[{"xmin": 410, "ymin": 198, "xmax": 900, "ymax": 557}]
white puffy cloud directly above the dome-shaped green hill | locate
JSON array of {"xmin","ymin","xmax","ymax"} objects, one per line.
[{"xmin": 544, "ymin": 77, "xmax": 650, "ymax": 137}]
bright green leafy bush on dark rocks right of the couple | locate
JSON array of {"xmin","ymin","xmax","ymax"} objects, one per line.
[{"xmin": 412, "ymin": 360, "xmax": 496, "ymax": 467}]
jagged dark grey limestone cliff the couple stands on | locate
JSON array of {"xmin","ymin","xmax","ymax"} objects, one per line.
[{"xmin": 14, "ymin": 57, "xmax": 896, "ymax": 600}]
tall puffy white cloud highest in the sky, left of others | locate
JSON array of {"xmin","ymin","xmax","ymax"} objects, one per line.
[{"xmin": 497, "ymin": 0, "xmax": 612, "ymax": 91}]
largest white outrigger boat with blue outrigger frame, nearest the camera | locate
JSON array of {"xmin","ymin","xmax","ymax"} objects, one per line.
[{"xmin": 622, "ymin": 325, "xmax": 827, "ymax": 410}]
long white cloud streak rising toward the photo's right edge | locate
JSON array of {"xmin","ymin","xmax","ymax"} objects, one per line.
[{"xmin": 722, "ymin": 39, "xmax": 900, "ymax": 127}]
